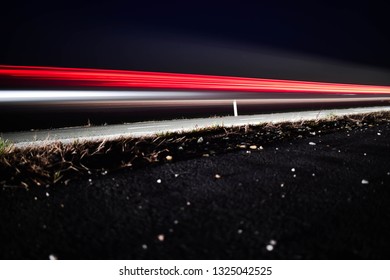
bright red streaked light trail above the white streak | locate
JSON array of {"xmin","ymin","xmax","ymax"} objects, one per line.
[{"xmin": 0, "ymin": 65, "xmax": 390, "ymax": 94}]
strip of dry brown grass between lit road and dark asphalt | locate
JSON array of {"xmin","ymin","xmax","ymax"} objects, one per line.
[{"xmin": 0, "ymin": 112, "xmax": 390, "ymax": 188}]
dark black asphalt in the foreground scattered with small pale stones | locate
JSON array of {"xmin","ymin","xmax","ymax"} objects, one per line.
[{"xmin": 0, "ymin": 119, "xmax": 390, "ymax": 259}]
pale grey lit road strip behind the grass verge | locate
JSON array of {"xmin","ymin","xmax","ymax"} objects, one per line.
[{"xmin": 0, "ymin": 106, "xmax": 390, "ymax": 147}]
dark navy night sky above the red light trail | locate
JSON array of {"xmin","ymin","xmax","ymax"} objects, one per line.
[{"xmin": 0, "ymin": 1, "xmax": 390, "ymax": 84}]
